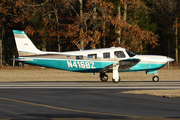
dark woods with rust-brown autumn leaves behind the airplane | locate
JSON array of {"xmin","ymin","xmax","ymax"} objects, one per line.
[{"xmin": 0, "ymin": 0, "xmax": 180, "ymax": 66}]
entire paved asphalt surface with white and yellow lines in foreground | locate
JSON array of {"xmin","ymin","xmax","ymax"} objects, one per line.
[{"xmin": 0, "ymin": 81, "xmax": 180, "ymax": 120}]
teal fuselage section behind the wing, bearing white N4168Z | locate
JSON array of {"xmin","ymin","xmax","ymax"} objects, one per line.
[{"xmin": 23, "ymin": 58, "xmax": 116, "ymax": 72}]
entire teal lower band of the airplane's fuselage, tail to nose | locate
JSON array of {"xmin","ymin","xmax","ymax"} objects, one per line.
[{"xmin": 23, "ymin": 58, "xmax": 165, "ymax": 72}]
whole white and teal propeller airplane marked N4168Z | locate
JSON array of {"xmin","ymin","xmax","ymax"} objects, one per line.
[{"xmin": 13, "ymin": 30, "xmax": 174, "ymax": 83}]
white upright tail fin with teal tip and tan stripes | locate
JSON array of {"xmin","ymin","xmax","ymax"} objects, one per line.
[{"xmin": 13, "ymin": 30, "xmax": 41, "ymax": 56}]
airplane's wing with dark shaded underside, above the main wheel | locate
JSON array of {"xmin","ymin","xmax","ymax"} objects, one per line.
[{"xmin": 99, "ymin": 58, "xmax": 141, "ymax": 72}]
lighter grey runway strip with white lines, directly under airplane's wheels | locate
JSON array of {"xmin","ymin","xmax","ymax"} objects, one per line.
[{"xmin": 0, "ymin": 81, "xmax": 180, "ymax": 89}]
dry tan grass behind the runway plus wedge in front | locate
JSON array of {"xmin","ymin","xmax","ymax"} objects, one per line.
[{"xmin": 0, "ymin": 66, "xmax": 180, "ymax": 98}]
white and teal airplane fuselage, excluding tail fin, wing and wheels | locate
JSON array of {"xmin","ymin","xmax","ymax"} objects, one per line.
[{"xmin": 19, "ymin": 47, "xmax": 171, "ymax": 72}]
